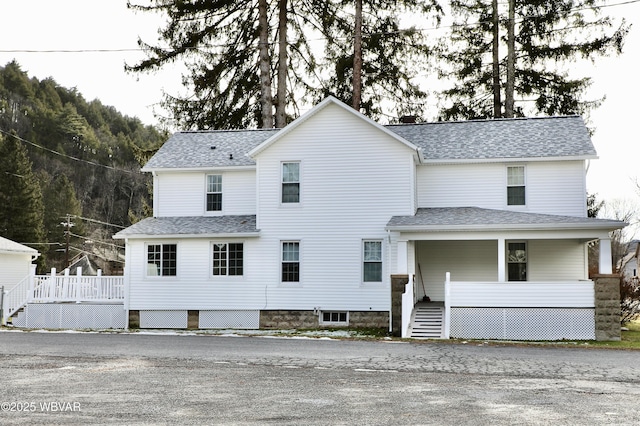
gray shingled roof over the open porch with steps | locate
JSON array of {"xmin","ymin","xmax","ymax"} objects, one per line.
[{"xmin": 386, "ymin": 207, "xmax": 627, "ymax": 232}]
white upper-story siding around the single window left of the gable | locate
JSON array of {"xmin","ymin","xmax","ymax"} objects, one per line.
[{"xmin": 154, "ymin": 170, "xmax": 256, "ymax": 217}]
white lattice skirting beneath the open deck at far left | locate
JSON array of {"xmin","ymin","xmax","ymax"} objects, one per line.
[{"xmin": 14, "ymin": 303, "xmax": 126, "ymax": 330}]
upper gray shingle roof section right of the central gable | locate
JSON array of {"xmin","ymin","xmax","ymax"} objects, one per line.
[{"xmin": 387, "ymin": 116, "xmax": 597, "ymax": 161}]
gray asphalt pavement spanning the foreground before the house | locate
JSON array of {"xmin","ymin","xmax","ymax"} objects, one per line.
[{"xmin": 0, "ymin": 331, "xmax": 640, "ymax": 425}]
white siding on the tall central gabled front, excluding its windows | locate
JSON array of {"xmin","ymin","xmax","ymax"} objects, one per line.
[{"xmin": 250, "ymin": 105, "xmax": 415, "ymax": 311}]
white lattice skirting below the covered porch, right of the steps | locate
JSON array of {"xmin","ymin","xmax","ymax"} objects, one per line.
[{"xmin": 450, "ymin": 308, "xmax": 595, "ymax": 340}]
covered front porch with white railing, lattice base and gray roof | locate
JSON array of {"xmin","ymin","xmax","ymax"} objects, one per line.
[{"xmin": 387, "ymin": 208, "xmax": 625, "ymax": 340}]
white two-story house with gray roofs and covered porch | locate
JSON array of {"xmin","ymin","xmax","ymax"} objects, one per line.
[{"xmin": 116, "ymin": 98, "xmax": 624, "ymax": 339}]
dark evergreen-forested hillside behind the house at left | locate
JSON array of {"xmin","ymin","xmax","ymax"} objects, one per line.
[{"xmin": 0, "ymin": 61, "xmax": 168, "ymax": 272}]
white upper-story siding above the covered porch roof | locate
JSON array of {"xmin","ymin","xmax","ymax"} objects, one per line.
[{"xmin": 417, "ymin": 160, "xmax": 586, "ymax": 217}]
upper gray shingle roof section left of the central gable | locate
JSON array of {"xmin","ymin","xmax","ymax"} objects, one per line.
[{"xmin": 143, "ymin": 129, "xmax": 279, "ymax": 170}]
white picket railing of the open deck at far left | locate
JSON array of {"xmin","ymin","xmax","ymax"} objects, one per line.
[{"xmin": 2, "ymin": 266, "xmax": 124, "ymax": 322}]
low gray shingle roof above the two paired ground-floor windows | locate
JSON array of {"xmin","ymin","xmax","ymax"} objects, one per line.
[{"xmin": 114, "ymin": 215, "xmax": 259, "ymax": 238}]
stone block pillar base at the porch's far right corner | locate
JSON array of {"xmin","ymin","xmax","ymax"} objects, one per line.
[{"xmin": 592, "ymin": 274, "xmax": 621, "ymax": 341}]
